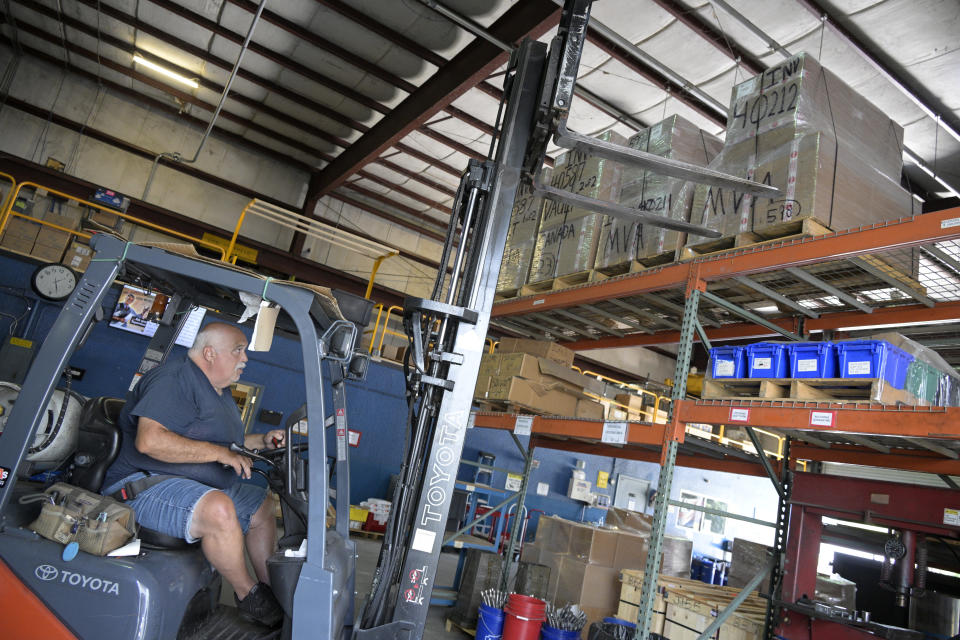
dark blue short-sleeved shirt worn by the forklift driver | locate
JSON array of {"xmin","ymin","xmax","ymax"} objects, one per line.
[{"xmin": 103, "ymin": 358, "xmax": 243, "ymax": 489}]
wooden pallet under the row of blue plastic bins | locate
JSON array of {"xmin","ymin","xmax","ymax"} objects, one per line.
[{"xmin": 700, "ymin": 378, "xmax": 917, "ymax": 405}]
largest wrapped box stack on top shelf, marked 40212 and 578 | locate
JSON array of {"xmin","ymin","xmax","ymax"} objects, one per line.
[{"xmin": 688, "ymin": 53, "xmax": 913, "ymax": 245}]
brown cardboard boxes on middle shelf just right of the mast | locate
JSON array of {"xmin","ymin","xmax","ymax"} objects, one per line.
[{"xmin": 474, "ymin": 338, "xmax": 604, "ymax": 420}]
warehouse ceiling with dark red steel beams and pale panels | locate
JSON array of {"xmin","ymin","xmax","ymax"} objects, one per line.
[{"xmin": 2, "ymin": 0, "xmax": 960, "ymax": 270}]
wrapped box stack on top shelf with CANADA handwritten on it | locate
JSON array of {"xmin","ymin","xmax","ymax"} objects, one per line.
[{"xmin": 528, "ymin": 131, "xmax": 626, "ymax": 284}]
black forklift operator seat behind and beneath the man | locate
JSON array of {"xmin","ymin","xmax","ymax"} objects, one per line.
[{"xmin": 68, "ymin": 397, "xmax": 195, "ymax": 549}]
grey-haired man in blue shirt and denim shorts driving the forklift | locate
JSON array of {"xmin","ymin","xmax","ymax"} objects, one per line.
[{"xmin": 103, "ymin": 322, "xmax": 285, "ymax": 626}]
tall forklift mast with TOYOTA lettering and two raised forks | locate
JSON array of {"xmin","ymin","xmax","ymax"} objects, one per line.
[{"xmin": 354, "ymin": 0, "xmax": 778, "ymax": 640}]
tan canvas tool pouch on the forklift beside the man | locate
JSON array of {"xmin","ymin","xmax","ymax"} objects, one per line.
[{"xmin": 29, "ymin": 482, "xmax": 136, "ymax": 556}]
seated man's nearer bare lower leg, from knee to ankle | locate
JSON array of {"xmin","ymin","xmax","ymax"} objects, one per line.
[{"xmin": 190, "ymin": 491, "xmax": 255, "ymax": 600}]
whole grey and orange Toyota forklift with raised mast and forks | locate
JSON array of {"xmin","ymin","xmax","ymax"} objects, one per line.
[{"xmin": 0, "ymin": 0, "xmax": 777, "ymax": 640}]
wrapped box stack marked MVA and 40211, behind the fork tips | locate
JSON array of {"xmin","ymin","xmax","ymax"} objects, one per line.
[{"xmin": 595, "ymin": 115, "xmax": 723, "ymax": 270}]
